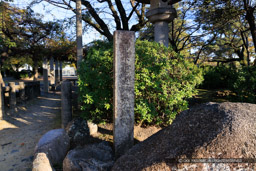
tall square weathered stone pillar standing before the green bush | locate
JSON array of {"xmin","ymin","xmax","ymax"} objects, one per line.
[{"xmin": 113, "ymin": 31, "xmax": 135, "ymax": 158}]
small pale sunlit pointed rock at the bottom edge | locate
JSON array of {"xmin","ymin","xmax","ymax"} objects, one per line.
[{"xmin": 32, "ymin": 153, "xmax": 53, "ymax": 171}]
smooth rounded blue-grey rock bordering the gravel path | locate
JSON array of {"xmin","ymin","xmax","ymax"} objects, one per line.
[{"xmin": 35, "ymin": 129, "xmax": 69, "ymax": 165}]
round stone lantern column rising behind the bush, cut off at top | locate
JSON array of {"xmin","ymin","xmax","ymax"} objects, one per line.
[{"xmin": 137, "ymin": 0, "xmax": 176, "ymax": 47}]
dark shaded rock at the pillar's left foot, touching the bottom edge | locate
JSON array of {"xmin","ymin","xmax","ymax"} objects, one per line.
[{"xmin": 63, "ymin": 142, "xmax": 114, "ymax": 171}]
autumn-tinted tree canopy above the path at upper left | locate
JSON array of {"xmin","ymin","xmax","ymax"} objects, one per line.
[{"xmin": 0, "ymin": 1, "xmax": 75, "ymax": 82}]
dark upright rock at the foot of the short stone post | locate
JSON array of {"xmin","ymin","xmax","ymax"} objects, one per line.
[{"xmin": 66, "ymin": 118, "xmax": 91, "ymax": 148}]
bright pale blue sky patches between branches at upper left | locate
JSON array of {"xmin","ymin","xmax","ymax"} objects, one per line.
[{"xmin": 11, "ymin": 0, "xmax": 101, "ymax": 45}]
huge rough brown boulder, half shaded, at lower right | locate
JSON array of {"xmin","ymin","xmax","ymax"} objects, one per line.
[{"xmin": 112, "ymin": 102, "xmax": 256, "ymax": 171}]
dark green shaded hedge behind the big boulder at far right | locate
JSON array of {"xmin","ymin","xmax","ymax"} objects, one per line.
[{"xmin": 200, "ymin": 66, "xmax": 256, "ymax": 103}]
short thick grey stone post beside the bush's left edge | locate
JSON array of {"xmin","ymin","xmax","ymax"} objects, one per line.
[{"xmin": 61, "ymin": 80, "xmax": 72, "ymax": 128}]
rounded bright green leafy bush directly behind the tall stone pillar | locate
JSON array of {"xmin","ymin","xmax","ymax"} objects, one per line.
[{"xmin": 78, "ymin": 41, "xmax": 202, "ymax": 124}]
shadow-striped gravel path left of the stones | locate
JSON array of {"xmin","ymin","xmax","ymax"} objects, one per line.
[{"xmin": 0, "ymin": 93, "xmax": 61, "ymax": 171}]
